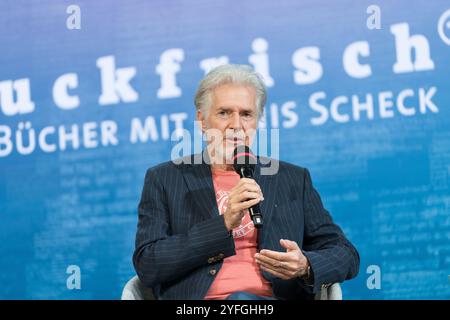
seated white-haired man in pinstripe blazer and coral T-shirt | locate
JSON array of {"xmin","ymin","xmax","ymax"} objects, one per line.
[{"xmin": 133, "ymin": 65, "xmax": 359, "ymax": 299}]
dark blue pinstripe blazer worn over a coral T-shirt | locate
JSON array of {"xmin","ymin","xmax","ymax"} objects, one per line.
[{"xmin": 133, "ymin": 153, "xmax": 359, "ymax": 299}]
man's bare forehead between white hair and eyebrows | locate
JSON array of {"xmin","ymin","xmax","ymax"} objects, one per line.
[{"xmin": 212, "ymin": 84, "xmax": 256, "ymax": 109}]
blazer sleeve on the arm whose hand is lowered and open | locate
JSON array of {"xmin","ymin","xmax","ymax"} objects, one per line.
[{"xmin": 303, "ymin": 169, "xmax": 360, "ymax": 293}]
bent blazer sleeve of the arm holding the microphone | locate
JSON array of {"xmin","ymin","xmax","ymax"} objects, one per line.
[{"xmin": 133, "ymin": 169, "xmax": 235, "ymax": 287}]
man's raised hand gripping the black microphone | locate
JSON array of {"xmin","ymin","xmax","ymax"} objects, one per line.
[{"xmin": 223, "ymin": 178, "xmax": 264, "ymax": 231}]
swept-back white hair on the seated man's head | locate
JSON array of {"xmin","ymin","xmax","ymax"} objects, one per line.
[{"xmin": 194, "ymin": 64, "xmax": 267, "ymax": 118}]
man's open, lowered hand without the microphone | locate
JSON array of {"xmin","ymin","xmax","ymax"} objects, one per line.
[{"xmin": 255, "ymin": 239, "xmax": 309, "ymax": 280}]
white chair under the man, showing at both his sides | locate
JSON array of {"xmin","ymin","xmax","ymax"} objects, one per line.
[{"xmin": 121, "ymin": 276, "xmax": 342, "ymax": 300}]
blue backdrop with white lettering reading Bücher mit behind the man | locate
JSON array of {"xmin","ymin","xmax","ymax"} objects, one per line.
[{"xmin": 0, "ymin": 0, "xmax": 450, "ymax": 299}]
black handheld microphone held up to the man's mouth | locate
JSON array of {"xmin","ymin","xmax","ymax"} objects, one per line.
[{"xmin": 233, "ymin": 145, "xmax": 263, "ymax": 228}]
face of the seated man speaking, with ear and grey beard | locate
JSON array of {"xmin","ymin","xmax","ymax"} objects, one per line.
[{"xmin": 197, "ymin": 84, "xmax": 258, "ymax": 163}]
